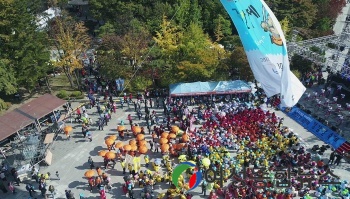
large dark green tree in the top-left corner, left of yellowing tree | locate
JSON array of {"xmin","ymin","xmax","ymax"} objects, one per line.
[{"xmin": 0, "ymin": 0, "xmax": 50, "ymax": 91}]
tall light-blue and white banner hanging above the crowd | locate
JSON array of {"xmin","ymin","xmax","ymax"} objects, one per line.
[{"xmin": 220, "ymin": 0, "xmax": 306, "ymax": 107}]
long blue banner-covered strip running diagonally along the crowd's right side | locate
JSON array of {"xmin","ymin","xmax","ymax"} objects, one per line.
[{"xmin": 282, "ymin": 107, "xmax": 346, "ymax": 149}]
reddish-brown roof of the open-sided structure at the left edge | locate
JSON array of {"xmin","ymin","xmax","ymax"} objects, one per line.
[{"xmin": 0, "ymin": 94, "xmax": 66, "ymax": 140}]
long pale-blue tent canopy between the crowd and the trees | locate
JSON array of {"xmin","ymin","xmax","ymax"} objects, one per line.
[{"xmin": 169, "ymin": 80, "xmax": 252, "ymax": 97}]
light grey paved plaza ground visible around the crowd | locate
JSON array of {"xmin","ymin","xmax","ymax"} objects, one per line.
[{"xmin": 0, "ymin": 98, "xmax": 350, "ymax": 199}]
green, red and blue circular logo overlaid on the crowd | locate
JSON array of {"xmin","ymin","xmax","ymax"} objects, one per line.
[{"xmin": 171, "ymin": 162, "xmax": 202, "ymax": 191}]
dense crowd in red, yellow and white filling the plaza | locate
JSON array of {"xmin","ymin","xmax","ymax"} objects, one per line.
[{"xmin": 76, "ymin": 87, "xmax": 349, "ymax": 199}]
